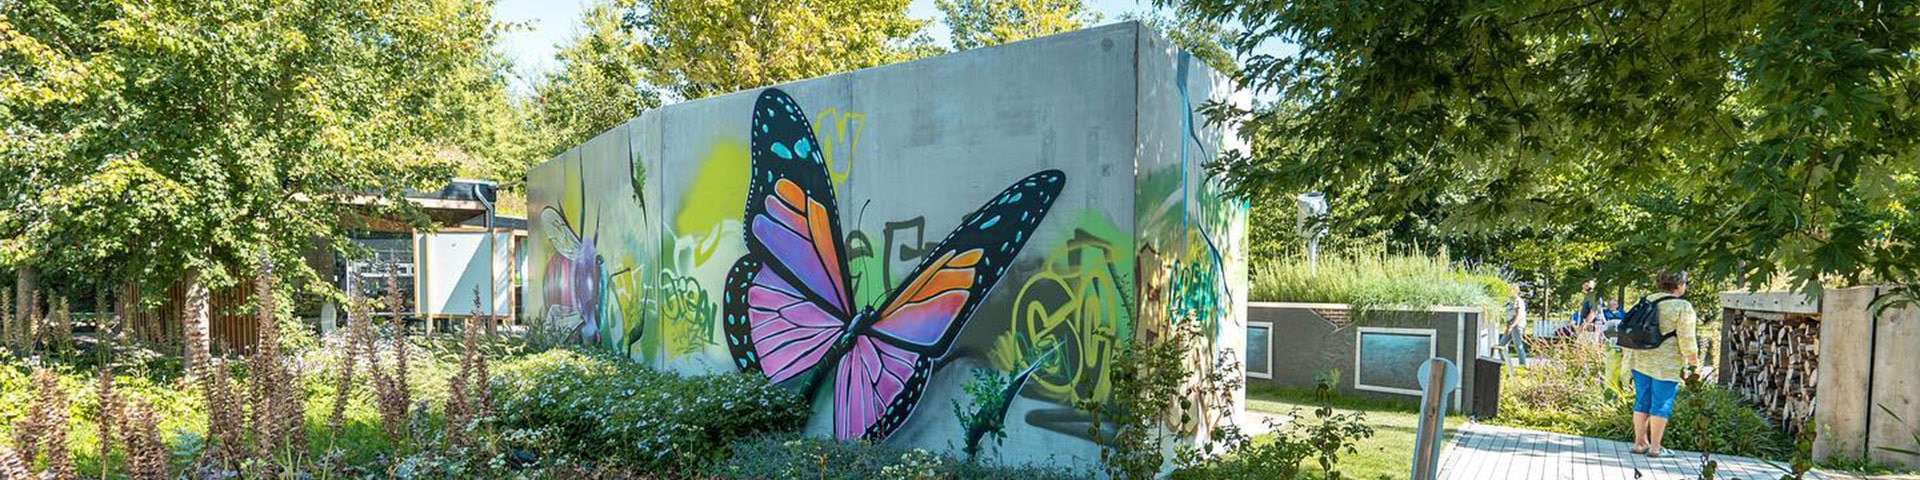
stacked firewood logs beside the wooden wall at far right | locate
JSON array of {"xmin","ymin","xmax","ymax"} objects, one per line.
[{"xmin": 1722, "ymin": 309, "xmax": 1820, "ymax": 434}]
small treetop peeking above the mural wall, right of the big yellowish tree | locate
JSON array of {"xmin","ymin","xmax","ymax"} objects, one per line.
[{"xmin": 933, "ymin": 0, "xmax": 1100, "ymax": 50}]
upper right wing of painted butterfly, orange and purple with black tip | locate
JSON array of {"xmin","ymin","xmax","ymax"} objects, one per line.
[{"xmin": 872, "ymin": 171, "xmax": 1066, "ymax": 357}]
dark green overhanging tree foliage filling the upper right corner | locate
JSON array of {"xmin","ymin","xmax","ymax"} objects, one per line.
[{"xmin": 1181, "ymin": 0, "xmax": 1920, "ymax": 292}]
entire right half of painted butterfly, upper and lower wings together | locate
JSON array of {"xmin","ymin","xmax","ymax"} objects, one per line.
[{"xmin": 833, "ymin": 171, "xmax": 1066, "ymax": 440}]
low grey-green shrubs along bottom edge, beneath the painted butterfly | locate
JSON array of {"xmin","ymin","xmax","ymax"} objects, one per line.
[{"xmin": 707, "ymin": 436, "xmax": 1089, "ymax": 480}]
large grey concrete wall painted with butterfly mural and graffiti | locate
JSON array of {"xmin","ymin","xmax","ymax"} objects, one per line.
[{"xmin": 524, "ymin": 23, "xmax": 1246, "ymax": 465}]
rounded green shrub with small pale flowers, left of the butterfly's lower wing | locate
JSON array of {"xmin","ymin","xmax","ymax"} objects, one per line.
[{"xmin": 492, "ymin": 349, "xmax": 808, "ymax": 470}]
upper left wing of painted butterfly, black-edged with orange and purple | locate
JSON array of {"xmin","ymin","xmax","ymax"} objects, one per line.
[{"xmin": 747, "ymin": 88, "xmax": 852, "ymax": 317}]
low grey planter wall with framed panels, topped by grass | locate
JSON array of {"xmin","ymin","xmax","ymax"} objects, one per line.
[{"xmin": 1248, "ymin": 301, "xmax": 1498, "ymax": 411}]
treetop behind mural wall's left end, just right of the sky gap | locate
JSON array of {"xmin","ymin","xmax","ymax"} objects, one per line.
[{"xmin": 532, "ymin": 0, "xmax": 660, "ymax": 159}]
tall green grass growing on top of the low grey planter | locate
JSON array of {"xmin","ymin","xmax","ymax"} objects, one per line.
[{"xmin": 1252, "ymin": 250, "xmax": 1513, "ymax": 309}]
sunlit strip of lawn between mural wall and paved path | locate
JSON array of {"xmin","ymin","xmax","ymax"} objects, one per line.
[{"xmin": 1246, "ymin": 386, "xmax": 1467, "ymax": 480}]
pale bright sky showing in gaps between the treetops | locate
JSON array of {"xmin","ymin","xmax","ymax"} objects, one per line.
[{"xmin": 493, "ymin": 0, "xmax": 1152, "ymax": 88}]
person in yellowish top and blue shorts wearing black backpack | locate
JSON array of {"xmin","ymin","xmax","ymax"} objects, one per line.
[{"xmin": 1622, "ymin": 273, "xmax": 1699, "ymax": 457}]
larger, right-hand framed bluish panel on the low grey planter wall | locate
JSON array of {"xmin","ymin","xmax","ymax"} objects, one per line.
[{"xmin": 1354, "ymin": 326, "xmax": 1436, "ymax": 396}]
